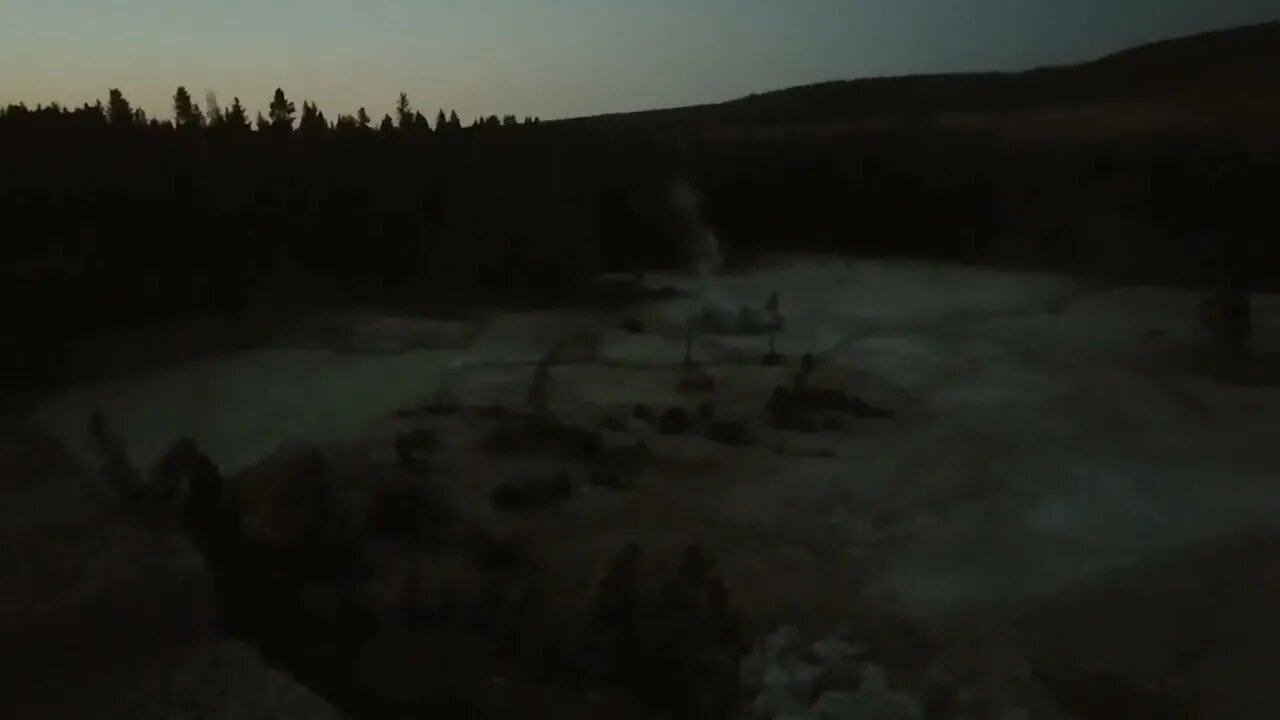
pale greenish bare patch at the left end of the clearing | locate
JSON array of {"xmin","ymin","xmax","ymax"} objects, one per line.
[{"xmin": 32, "ymin": 350, "xmax": 451, "ymax": 471}]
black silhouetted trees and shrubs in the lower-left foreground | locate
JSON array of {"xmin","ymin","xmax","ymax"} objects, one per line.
[{"xmin": 80, "ymin": 415, "xmax": 748, "ymax": 719}]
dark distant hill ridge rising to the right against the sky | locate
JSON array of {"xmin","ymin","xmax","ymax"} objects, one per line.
[{"xmin": 559, "ymin": 22, "xmax": 1280, "ymax": 131}]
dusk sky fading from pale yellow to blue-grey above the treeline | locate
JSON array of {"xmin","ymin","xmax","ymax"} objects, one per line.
[{"xmin": 0, "ymin": 0, "xmax": 1280, "ymax": 119}]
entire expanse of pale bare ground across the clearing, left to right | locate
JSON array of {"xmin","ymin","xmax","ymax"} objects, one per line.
[{"xmin": 24, "ymin": 259, "xmax": 1280, "ymax": 616}]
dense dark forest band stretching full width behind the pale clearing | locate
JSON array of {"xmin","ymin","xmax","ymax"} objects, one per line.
[{"xmin": 0, "ymin": 77, "xmax": 1280, "ymax": 397}]
